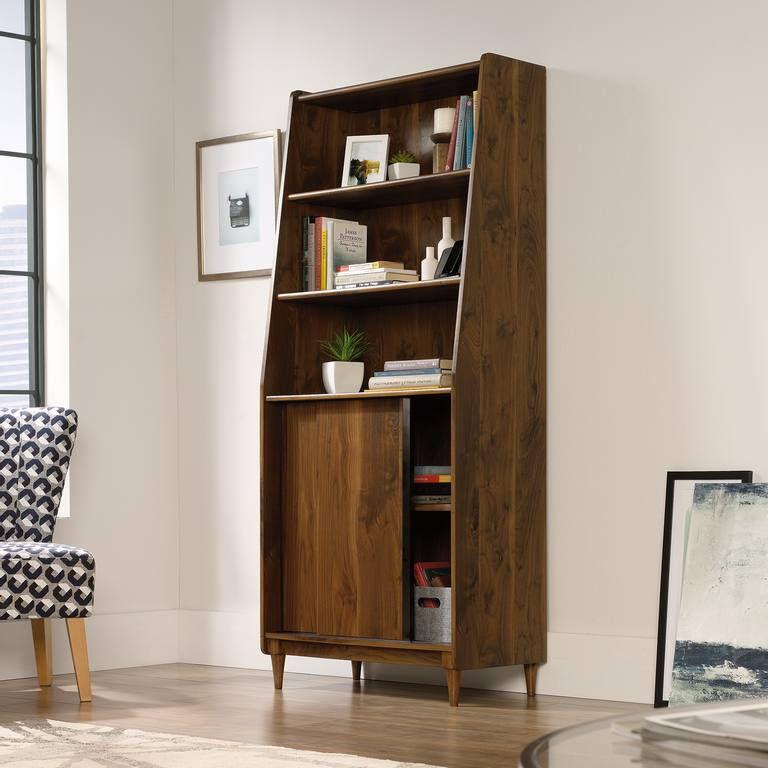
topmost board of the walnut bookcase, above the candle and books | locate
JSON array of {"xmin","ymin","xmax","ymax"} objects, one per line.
[{"xmin": 298, "ymin": 61, "xmax": 480, "ymax": 112}]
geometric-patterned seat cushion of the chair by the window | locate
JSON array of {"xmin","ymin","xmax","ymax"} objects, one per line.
[{"xmin": 0, "ymin": 541, "xmax": 95, "ymax": 621}]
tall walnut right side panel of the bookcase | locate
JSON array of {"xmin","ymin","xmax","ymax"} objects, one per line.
[{"xmin": 452, "ymin": 54, "xmax": 546, "ymax": 669}]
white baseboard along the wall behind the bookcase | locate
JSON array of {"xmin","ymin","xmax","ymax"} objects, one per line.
[{"xmin": 179, "ymin": 610, "xmax": 656, "ymax": 704}]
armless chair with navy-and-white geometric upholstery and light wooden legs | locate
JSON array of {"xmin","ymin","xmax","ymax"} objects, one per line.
[{"xmin": 0, "ymin": 408, "xmax": 95, "ymax": 701}]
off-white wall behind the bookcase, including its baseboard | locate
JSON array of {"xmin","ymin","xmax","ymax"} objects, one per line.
[{"xmin": 174, "ymin": 0, "xmax": 768, "ymax": 701}]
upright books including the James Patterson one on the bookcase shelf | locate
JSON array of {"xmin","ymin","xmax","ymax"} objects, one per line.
[{"xmin": 301, "ymin": 216, "xmax": 368, "ymax": 291}]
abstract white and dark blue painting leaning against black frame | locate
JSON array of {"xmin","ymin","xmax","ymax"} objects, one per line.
[{"xmin": 669, "ymin": 483, "xmax": 768, "ymax": 705}]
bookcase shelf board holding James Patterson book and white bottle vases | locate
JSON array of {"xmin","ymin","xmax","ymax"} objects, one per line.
[{"xmin": 277, "ymin": 277, "xmax": 461, "ymax": 306}]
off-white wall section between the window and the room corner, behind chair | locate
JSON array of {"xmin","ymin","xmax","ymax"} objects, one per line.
[{"xmin": 0, "ymin": 0, "xmax": 178, "ymax": 677}]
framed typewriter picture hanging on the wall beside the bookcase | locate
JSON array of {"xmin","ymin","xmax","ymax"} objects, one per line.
[{"xmin": 195, "ymin": 130, "xmax": 281, "ymax": 280}]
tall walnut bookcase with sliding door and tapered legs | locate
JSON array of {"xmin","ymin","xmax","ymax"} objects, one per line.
[{"xmin": 261, "ymin": 54, "xmax": 546, "ymax": 705}]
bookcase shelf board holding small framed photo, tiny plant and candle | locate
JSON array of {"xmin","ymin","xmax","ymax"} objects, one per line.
[{"xmin": 288, "ymin": 168, "xmax": 470, "ymax": 208}]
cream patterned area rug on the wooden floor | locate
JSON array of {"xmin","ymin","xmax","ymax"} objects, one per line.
[{"xmin": 0, "ymin": 720, "xmax": 434, "ymax": 768}]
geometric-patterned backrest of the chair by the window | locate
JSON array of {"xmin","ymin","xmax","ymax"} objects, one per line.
[{"xmin": 0, "ymin": 408, "xmax": 77, "ymax": 542}]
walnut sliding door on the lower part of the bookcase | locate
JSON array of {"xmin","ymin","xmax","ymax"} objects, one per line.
[{"xmin": 283, "ymin": 398, "xmax": 407, "ymax": 639}]
